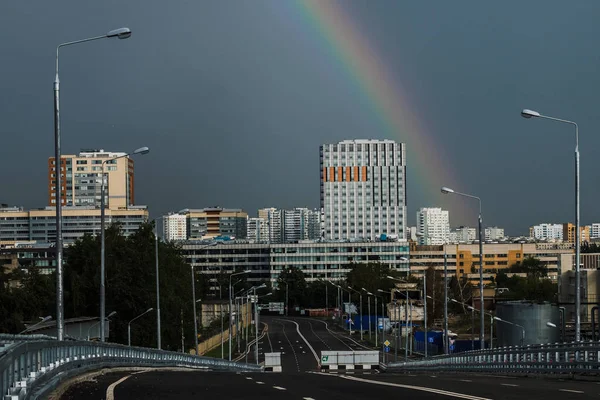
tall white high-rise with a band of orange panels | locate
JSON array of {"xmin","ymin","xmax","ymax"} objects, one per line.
[{"xmin": 319, "ymin": 140, "xmax": 406, "ymax": 240}]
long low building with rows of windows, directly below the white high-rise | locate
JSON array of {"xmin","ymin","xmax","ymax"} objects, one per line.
[{"xmin": 182, "ymin": 240, "xmax": 409, "ymax": 295}]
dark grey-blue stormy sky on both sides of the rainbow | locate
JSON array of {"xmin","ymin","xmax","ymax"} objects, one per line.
[{"xmin": 0, "ymin": 0, "xmax": 600, "ymax": 235}]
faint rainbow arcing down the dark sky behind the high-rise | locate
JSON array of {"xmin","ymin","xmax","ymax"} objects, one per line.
[{"xmin": 284, "ymin": 0, "xmax": 466, "ymax": 219}]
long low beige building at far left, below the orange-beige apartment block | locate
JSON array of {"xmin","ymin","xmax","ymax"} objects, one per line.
[{"xmin": 0, "ymin": 206, "xmax": 148, "ymax": 244}]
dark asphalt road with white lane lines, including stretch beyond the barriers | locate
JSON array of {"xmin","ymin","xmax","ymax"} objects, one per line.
[{"xmin": 62, "ymin": 317, "xmax": 600, "ymax": 400}]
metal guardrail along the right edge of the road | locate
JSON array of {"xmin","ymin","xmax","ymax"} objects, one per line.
[{"xmin": 387, "ymin": 342, "xmax": 600, "ymax": 374}]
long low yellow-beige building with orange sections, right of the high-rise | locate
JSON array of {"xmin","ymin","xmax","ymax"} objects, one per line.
[{"xmin": 410, "ymin": 243, "xmax": 574, "ymax": 283}]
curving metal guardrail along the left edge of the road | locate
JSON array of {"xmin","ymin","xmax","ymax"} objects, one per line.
[{"xmin": 0, "ymin": 339, "xmax": 262, "ymax": 400}]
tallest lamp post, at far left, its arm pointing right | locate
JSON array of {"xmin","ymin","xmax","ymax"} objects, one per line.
[{"xmin": 54, "ymin": 28, "xmax": 131, "ymax": 340}]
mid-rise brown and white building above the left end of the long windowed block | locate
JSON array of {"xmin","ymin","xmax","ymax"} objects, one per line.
[{"xmin": 178, "ymin": 207, "xmax": 248, "ymax": 240}]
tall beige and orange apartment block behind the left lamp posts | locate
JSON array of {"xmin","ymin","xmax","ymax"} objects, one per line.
[{"xmin": 48, "ymin": 150, "xmax": 135, "ymax": 209}]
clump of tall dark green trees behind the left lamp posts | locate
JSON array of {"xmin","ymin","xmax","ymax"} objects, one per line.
[{"xmin": 65, "ymin": 223, "xmax": 199, "ymax": 350}]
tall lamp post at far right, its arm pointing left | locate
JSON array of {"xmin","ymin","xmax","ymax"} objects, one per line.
[{"xmin": 521, "ymin": 109, "xmax": 581, "ymax": 342}]
